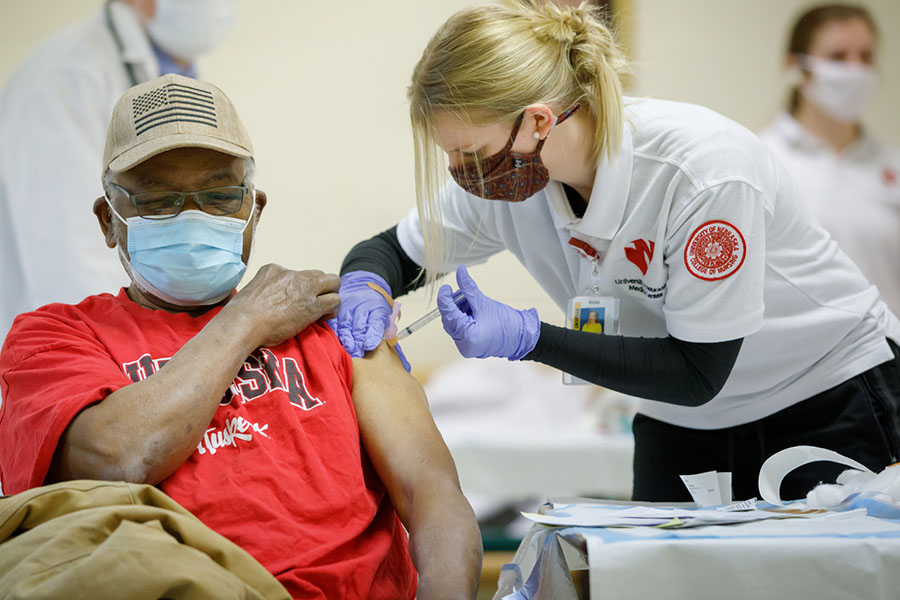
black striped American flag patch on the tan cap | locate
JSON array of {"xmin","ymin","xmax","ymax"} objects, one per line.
[{"xmin": 131, "ymin": 83, "xmax": 218, "ymax": 135}]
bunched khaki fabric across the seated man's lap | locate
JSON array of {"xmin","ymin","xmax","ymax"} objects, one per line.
[{"xmin": 0, "ymin": 481, "xmax": 290, "ymax": 600}]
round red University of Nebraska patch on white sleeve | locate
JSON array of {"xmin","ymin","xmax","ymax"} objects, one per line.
[{"xmin": 684, "ymin": 221, "xmax": 747, "ymax": 281}]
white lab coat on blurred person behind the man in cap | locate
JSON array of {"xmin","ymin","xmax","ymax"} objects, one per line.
[{"xmin": 0, "ymin": 2, "xmax": 159, "ymax": 341}]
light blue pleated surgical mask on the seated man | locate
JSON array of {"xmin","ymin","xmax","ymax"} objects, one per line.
[{"xmin": 107, "ymin": 200, "xmax": 256, "ymax": 306}]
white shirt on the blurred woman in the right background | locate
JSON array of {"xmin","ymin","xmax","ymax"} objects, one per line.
[{"xmin": 760, "ymin": 113, "xmax": 900, "ymax": 314}]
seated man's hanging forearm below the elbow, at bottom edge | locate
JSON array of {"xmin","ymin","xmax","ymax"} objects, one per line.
[{"xmin": 409, "ymin": 482, "xmax": 482, "ymax": 600}]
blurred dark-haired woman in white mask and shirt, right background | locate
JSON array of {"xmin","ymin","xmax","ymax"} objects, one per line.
[{"xmin": 760, "ymin": 4, "xmax": 900, "ymax": 314}]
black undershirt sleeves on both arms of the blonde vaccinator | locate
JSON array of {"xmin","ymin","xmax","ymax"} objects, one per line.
[{"xmin": 341, "ymin": 226, "xmax": 743, "ymax": 406}]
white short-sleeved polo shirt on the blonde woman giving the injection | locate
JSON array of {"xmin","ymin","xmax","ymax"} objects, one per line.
[{"xmin": 397, "ymin": 99, "xmax": 900, "ymax": 429}]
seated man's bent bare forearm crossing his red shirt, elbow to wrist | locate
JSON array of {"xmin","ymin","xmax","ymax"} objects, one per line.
[{"xmin": 47, "ymin": 306, "xmax": 258, "ymax": 484}]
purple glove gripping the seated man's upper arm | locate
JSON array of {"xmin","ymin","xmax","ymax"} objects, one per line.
[{"xmin": 328, "ymin": 271, "xmax": 392, "ymax": 358}]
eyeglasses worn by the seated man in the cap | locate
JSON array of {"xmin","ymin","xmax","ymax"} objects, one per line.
[{"xmin": 110, "ymin": 183, "xmax": 250, "ymax": 220}]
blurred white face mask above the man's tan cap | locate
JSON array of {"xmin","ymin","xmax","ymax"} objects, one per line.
[{"xmin": 147, "ymin": 0, "xmax": 235, "ymax": 62}]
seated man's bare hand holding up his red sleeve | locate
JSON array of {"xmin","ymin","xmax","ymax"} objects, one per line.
[{"xmin": 226, "ymin": 264, "xmax": 341, "ymax": 346}]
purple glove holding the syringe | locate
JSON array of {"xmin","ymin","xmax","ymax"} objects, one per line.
[{"xmin": 438, "ymin": 265, "xmax": 541, "ymax": 360}]
